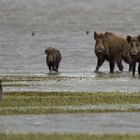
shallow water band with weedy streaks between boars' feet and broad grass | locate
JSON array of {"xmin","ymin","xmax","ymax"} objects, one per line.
[{"xmin": 1, "ymin": 73, "xmax": 140, "ymax": 92}]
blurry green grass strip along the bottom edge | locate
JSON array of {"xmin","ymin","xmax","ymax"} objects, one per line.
[{"xmin": 0, "ymin": 134, "xmax": 140, "ymax": 140}]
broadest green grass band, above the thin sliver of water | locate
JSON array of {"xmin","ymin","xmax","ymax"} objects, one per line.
[{"xmin": 0, "ymin": 92, "xmax": 140, "ymax": 107}]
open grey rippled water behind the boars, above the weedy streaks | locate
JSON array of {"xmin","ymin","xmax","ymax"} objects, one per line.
[{"xmin": 0, "ymin": 0, "xmax": 140, "ymax": 74}]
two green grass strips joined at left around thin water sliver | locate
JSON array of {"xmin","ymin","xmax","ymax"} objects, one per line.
[{"xmin": 0, "ymin": 92, "xmax": 140, "ymax": 115}]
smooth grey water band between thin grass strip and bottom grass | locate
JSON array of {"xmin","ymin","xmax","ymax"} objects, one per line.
[{"xmin": 0, "ymin": 113, "xmax": 140, "ymax": 134}]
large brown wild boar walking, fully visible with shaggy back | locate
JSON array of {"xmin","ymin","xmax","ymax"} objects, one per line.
[{"xmin": 94, "ymin": 32, "xmax": 132, "ymax": 73}]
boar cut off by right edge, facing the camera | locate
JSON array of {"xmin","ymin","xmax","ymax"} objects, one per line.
[{"xmin": 127, "ymin": 35, "xmax": 140, "ymax": 76}]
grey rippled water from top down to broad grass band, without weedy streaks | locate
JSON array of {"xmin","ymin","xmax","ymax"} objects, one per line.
[{"xmin": 0, "ymin": 0, "xmax": 140, "ymax": 91}]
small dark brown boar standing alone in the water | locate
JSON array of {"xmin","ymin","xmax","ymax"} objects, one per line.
[{"xmin": 45, "ymin": 47, "xmax": 62, "ymax": 72}]
